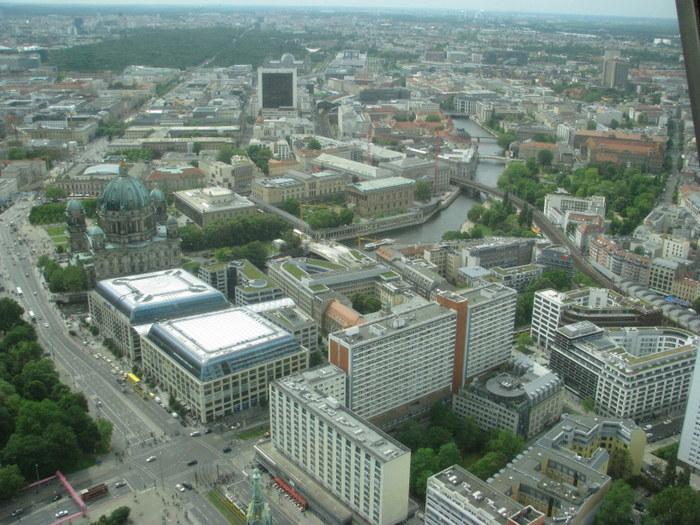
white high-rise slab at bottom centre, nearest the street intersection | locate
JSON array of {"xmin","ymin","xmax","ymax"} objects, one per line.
[{"xmin": 270, "ymin": 365, "xmax": 411, "ymax": 525}]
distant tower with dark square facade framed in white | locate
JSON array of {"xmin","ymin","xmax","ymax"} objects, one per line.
[{"xmin": 258, "ymin": 53, "xmax": 303, "ymax": 110}]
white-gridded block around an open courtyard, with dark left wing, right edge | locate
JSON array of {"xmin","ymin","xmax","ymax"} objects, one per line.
[{"xmin": 549, "ymin": 321, "xmax": 700, "ymax": 421}]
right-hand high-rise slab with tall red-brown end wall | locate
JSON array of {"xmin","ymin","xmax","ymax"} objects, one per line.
[{"xmin": 437, "ymin": 283, "xmax": 517, "ymax": 388}]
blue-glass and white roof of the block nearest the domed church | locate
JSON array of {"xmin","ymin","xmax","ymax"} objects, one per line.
[{"xmin": 95, "ymin": 268, "xmax": 229, "ymax": 324}]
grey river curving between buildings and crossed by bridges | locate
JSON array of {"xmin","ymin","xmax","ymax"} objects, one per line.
[{"xmin": 388, "ymin": 119, "xmax": 503, "ymax": 243}]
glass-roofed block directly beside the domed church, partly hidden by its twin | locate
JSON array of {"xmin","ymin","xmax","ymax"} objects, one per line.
[{"xmin": 88, "ymin": 268, "xmax": 230, "ymax": 364}]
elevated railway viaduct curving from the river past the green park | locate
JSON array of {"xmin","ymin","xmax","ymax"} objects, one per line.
[{"xmin": 450, "ymin": 176, "xmax": 618, "ymax": 290}]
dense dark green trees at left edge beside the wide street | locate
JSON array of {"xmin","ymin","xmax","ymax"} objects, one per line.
[{"xmin": 0, "ymin": 300, "xmax": 111, "ymax": 499}]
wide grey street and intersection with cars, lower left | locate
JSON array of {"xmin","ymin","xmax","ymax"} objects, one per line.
[{"xmin": 0, "ymin": 201, "xmax": 308, "ymax": 525}]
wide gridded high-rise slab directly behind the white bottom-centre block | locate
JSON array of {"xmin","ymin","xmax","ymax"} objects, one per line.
[{"xmin": 328, "ymin": 303, "xmax": 456, "ymax": 424}]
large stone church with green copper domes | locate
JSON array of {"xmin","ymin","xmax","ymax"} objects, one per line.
[{"xmin": 66, "ymin": 162, "xmax": 181, "ymax": 283}]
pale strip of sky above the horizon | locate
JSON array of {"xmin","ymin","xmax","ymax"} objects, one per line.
[{"xmin": 5, "ymin": 0, "xmax": 676, "ymax": 18}]
